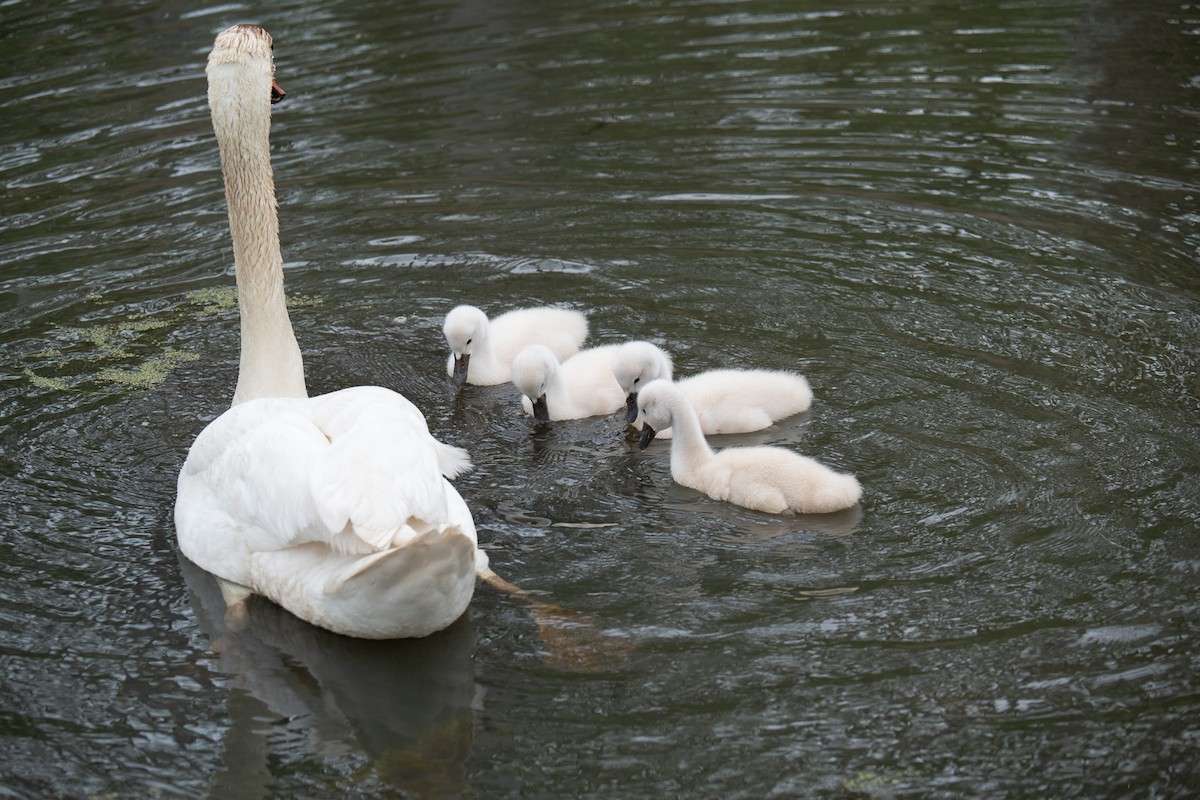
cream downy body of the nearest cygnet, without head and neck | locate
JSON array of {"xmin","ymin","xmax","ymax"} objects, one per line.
[{"xmin": 696, "ymin": 446, "xmax": 863, "ymax": 513}]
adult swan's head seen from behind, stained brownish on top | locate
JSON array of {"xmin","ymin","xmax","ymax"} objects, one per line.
[{"xmin": 205, "ymin": 25, "xmax": 284, "ymax": 128}]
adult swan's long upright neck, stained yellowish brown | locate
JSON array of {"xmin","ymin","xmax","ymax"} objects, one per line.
[{"xmin": 209, "ymin": 57, "xmax": 307, "ymax": 405}]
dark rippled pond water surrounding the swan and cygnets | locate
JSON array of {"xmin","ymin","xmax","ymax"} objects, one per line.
[{"xmin": 0, "ymin": 0, "xmax": 1200, "ymax": 799}]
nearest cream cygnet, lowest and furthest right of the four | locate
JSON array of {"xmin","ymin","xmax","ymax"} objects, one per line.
[{"xmin": 637, "ymin": 380, "xmax": 863, "ymax": 513}]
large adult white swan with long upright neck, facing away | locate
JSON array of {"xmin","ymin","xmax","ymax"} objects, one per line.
[{"xmin": 175, "ymin": 25, "xmax": 490, "ymax": 638}]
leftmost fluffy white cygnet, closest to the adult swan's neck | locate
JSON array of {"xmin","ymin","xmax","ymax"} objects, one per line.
[{"xmin": 442, "ymin": 306, "xmax": 588, "ymax": 386}]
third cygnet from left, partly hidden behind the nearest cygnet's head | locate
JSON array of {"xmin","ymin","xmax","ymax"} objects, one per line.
[{"xmin": 612, "ymin": 342, "xmax": 812, "ymax": 438}]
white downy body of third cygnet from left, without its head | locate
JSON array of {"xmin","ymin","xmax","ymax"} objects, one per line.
[{"xmin": 677, "ymin": 369, "xmax": 812, "ymax": 434}]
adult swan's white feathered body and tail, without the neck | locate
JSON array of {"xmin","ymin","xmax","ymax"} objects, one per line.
[{"xmin": 175, "ymin": 386, "xmax": 487, "ymax": 638}]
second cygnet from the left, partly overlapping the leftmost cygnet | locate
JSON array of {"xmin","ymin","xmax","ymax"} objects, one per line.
[{"xmin": 512, "ymin": 344, "xmax": 625, "ymax": 422}]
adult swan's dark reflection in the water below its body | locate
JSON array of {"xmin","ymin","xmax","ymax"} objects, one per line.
[{"xmin": 180, "ymin": 557, "xmax": 475, "ymax": 798}]
